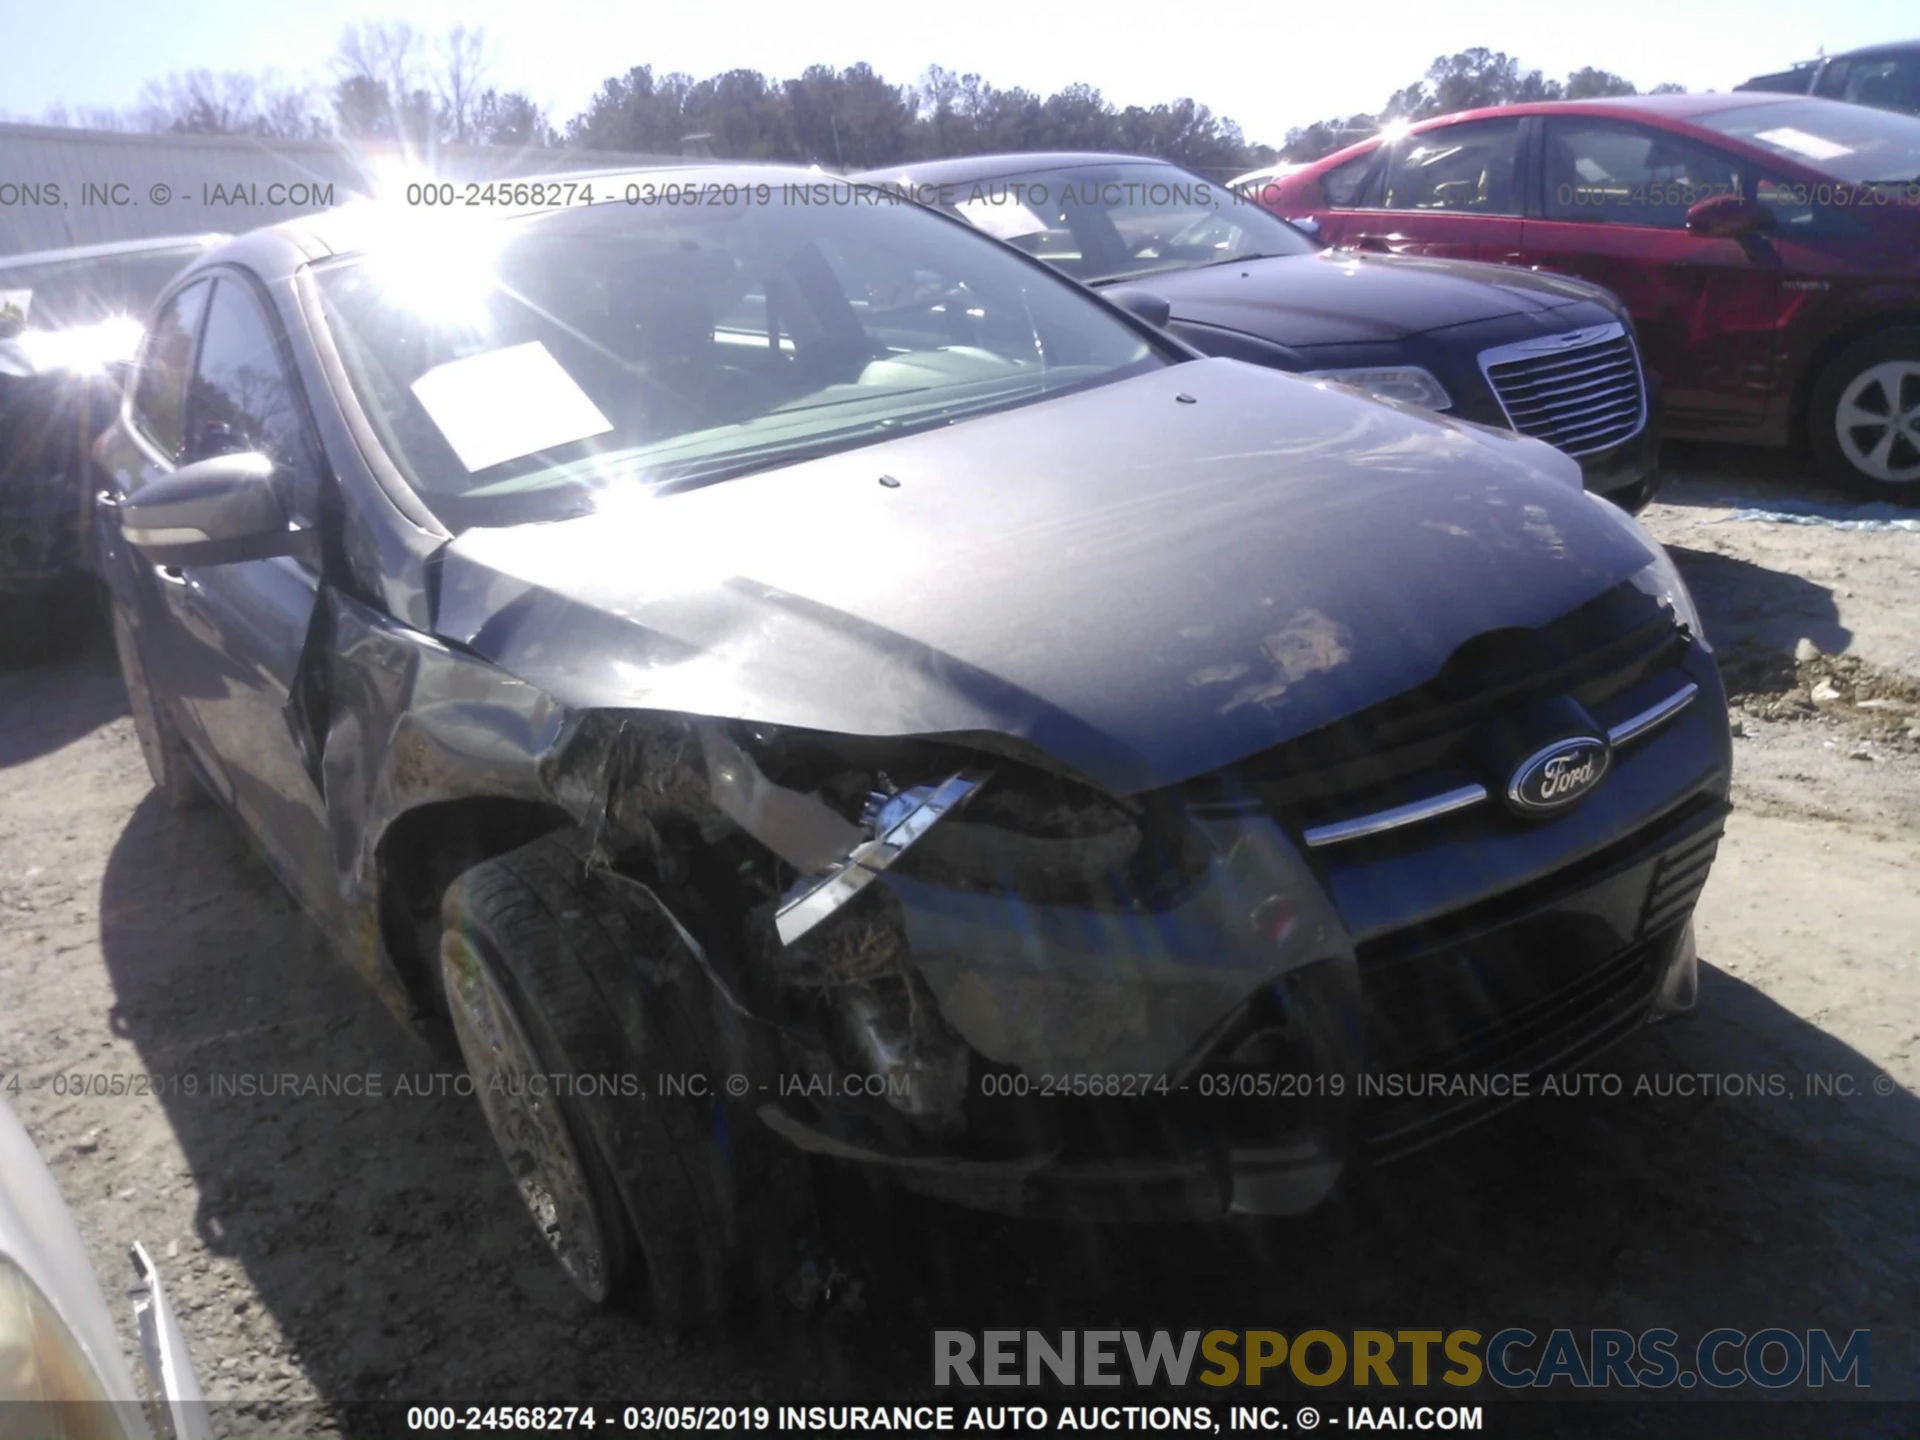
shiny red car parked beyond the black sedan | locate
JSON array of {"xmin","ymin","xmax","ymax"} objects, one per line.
[{"xmin": 1256, "ymin": 92, "xmax": 1920, "ymax": 503}]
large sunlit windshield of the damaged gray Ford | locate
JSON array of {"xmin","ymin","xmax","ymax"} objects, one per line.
[{"xmin": 319, "ymin": 182, "xmax": 1167, "ymax": 528}]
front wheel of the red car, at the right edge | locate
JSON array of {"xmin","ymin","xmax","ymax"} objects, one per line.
[{"xmin": 1807, "ymin": 326, "xmax": 1920, "ymax": 505}]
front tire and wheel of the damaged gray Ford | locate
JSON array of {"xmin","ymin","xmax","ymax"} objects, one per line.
[{"xmin": 440, "ymin": 833, "xmax": 797, "ymax": 1331}]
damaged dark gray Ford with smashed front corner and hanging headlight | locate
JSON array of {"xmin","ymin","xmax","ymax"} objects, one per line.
[{"xmin": 96, "ymin": 167, "xmax": 1730, "ymax": 1319}]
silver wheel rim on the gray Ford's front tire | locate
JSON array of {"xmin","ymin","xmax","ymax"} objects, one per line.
[{"xmin": 440, "ymin": 931, "xmax": 612, "ymax": 1304}]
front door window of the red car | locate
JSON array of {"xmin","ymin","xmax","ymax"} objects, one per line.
[{"xmin": 1546, "ymin": 119, "xmax": 1741, "ymax": 230}]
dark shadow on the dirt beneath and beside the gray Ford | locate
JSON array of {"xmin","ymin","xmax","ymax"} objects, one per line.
[{"xmin": 102, "ymin": 799, "xmax": 1920, "ymax": 1434}]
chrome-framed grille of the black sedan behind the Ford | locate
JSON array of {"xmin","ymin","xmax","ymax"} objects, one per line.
[{"xmin": 1480, "ymin": 324, "xmax": 1647, "ymax": 455}]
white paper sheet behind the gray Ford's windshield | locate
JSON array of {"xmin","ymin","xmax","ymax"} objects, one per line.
[{"xmin": 413, "ymin": 340, "xmax": 612, "ymax": 470}]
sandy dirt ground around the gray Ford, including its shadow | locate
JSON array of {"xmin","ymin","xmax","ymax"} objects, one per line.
[{"xmin": 0, "ymin": 449, "xmax": 1920, "ymax": 1434}]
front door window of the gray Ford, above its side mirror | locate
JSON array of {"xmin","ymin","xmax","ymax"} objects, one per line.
[{"xmin": 186, "ymin": 278, "xmax": 315, "ymax": 518}]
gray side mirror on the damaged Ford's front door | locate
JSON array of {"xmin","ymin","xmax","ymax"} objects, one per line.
[{"xmin": 119, "ymin": 451, "xmax": 296, "ymax": 564}]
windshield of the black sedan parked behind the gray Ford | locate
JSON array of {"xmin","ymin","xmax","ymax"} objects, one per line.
[{"xmin": 941, "ymin": 163, "xmax": 1319, "ymax": 284}]
